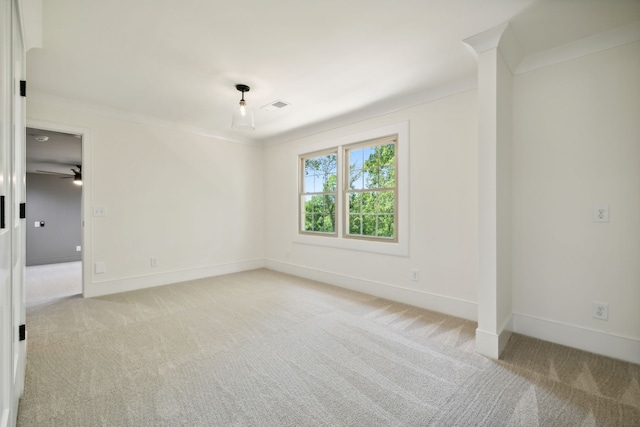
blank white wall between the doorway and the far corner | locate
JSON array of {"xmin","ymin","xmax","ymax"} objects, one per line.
[{"xmin": 28, "ymin": 102, "xmax": 263, "ymax": 296}]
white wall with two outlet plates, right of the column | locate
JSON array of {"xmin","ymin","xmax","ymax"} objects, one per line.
[{"xmin": 513, "ymin": 42, "xmax": 640, "ymax": 363}]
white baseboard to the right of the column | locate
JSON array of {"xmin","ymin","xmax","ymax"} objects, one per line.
[{"xmin": 513, "ymin": 313, "xmax": 640, "ymax": 364}]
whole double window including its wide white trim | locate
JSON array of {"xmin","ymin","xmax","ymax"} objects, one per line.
[{"xmin": 292, "ymin": 122, "xmax": 409, "ymax": 256}]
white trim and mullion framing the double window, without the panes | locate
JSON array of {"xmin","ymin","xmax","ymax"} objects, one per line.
[{"xmin": 292, "ymin": 121, "xmax": 409, "ymax": 257}]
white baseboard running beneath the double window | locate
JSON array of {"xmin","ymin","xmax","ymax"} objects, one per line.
[{"xmin": 264, "ymin": 259, "xmax": 478, "ymax": 321}]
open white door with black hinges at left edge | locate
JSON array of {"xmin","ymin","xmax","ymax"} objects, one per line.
[{"xmin": 0, "ymin": 0, "xmax": 26, "ymax": 427}]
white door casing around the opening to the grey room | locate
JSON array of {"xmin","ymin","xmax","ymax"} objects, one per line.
[{"xmin": 27, "ymin": 118, "xmax": 92, "ymax": 297}]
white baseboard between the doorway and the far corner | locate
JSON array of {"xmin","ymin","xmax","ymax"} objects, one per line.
[{"xmin": 83, "ymin": 259, "xmax": 264, "ymax": 298}]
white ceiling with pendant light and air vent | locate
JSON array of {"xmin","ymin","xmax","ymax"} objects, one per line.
[{"xmin": 27, "ymin": 0, "xmax": 640, "ymax": 142}]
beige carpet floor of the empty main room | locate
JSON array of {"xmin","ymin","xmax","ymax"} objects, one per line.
[{"xmin": 18, "ymin": 270, "xmax": 640, "ymax": 426}]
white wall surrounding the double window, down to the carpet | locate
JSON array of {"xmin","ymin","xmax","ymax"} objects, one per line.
[{"xmin": 265, "ymin": 91, "xmax": 478, "ymax": 319}]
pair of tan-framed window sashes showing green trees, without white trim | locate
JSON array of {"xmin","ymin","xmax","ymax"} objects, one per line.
[{"xmin": 299, "ymin": 136, "xmax": 397, "ymax": 241}]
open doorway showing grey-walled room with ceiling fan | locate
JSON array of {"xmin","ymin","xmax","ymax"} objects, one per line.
[{"xmin": 25, "ymin": 126, "xmax": 84, "ymax": 304}]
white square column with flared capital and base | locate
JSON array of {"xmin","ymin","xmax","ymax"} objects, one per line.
[{"xmin": 465, "ymin": 24, "xmax": 518, "ymax": 359}]
